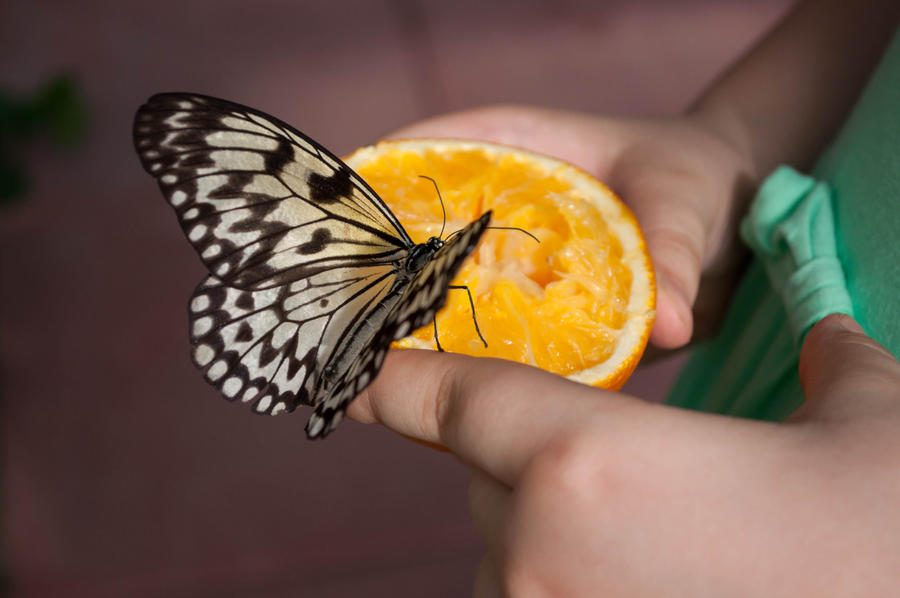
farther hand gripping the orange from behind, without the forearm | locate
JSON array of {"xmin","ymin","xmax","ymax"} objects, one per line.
[{"xmin": 384, "ymin": 106, "xmax": 752, "ymax": 347}]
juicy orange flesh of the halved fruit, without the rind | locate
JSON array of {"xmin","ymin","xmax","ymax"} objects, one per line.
[{"xmin": 357, "ymin": 149, "xmax": 632, "ymax": 375}]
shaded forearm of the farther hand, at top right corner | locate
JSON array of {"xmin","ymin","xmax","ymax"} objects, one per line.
[{"xmin": 689, "ymin": 0, "xmax": 900, "ymax": 182}]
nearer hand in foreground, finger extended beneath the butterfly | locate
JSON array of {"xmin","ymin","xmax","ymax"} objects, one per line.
[{"xmin": 350, "ymin": 316, "xmax": 900, "ymax": 598}]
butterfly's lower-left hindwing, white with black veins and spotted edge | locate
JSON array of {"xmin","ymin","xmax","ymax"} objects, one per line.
[{"xmin": 188, "ymin": 258, "xmax": 394, "ymax": 414}]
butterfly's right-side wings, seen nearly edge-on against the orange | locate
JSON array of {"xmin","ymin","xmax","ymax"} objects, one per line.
[{"xmin": 306, "ymin": 212, "xmax": 491, "ymax": 438}]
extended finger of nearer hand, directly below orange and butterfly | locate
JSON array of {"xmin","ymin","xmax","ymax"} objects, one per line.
[{"xmin": 348, "ymin": 350, "xmax": 616, "ymax": 486}]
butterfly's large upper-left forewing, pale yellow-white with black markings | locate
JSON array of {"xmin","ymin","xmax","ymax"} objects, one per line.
[{"xmin": 134, "ymin": 94, "xmax": 412, "ymax": 288}]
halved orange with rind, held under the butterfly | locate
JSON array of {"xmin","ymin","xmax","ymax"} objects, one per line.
[{"xmin": 346, "ymin": 139, "xmax": 656, "ymax": 389}]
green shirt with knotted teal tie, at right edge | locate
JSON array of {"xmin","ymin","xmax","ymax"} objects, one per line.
[{"xmin": 668, "ymin": 28, "xmax": 900, "ymax": 420}]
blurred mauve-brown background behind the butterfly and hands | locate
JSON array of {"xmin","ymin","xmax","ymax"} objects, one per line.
[{"xmin": 0, "ymin": 0, "xmax": 790, "ymax": 597}]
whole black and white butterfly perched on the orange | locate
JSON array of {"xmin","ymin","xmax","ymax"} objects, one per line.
[{"xmin": 134, "ymin": 93, "xmax": 490, "ymax": 438}]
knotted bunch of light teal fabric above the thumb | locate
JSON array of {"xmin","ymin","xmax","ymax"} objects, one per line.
[{"xmin": 741, "ymin": 166, "xmax": 853, "ymax": 348}]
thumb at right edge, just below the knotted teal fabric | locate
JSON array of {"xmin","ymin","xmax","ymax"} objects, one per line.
[{"xmin": 797, "ymin": 314, "xmax": 900, "ymax": 419}]
